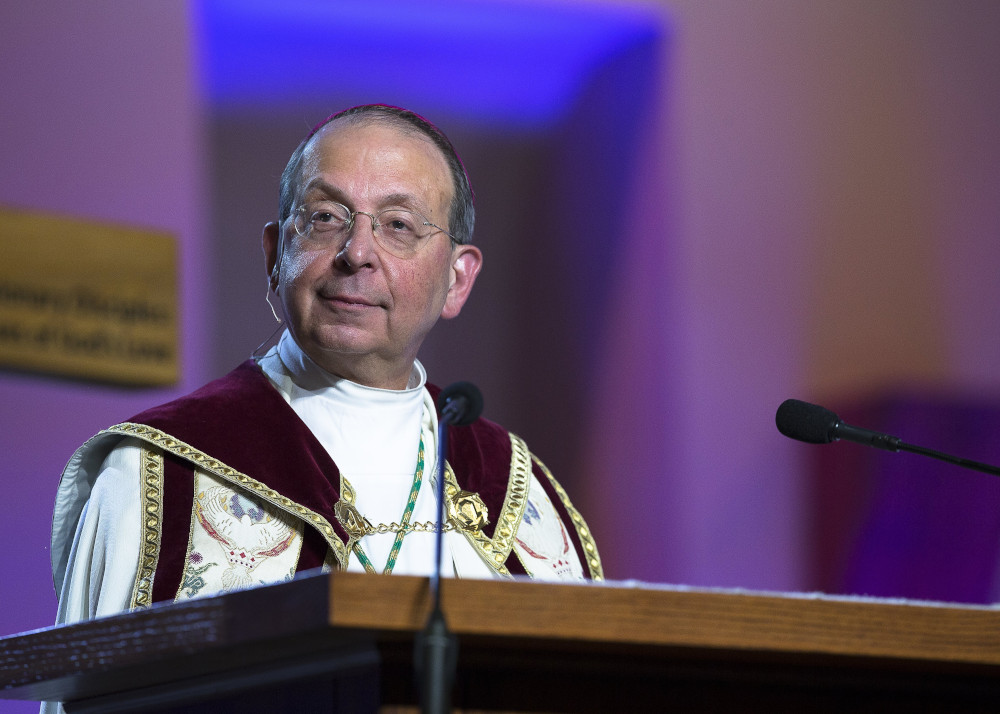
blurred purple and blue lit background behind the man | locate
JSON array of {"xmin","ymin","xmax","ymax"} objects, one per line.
[{"xmin": 0, "ymin": 0, "xmax": 1000, "ymax": 708}]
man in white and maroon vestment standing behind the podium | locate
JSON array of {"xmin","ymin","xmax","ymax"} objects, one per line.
[{"xmin": 52, "ymin": 105, "xmax": 602, "ymax": 622}]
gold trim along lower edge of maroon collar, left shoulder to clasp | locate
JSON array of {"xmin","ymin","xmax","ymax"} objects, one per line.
[{"xmin": 106, "ymin": 422, "xmax": 349, "ymax": 569}]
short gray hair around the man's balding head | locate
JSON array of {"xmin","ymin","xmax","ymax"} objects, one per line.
[{"xmin": 278, "ymin": 104, "xmax": 476, "ymax": 243}]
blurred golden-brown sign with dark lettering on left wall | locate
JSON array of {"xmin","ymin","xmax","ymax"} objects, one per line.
[{"xmin": 0, "ymin": 210, "xmax": 178, "ymax": 385}]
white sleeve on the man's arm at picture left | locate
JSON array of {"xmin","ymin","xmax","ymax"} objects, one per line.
[{"xmin": 56, "ymin": 439, "xmax": 141, "ymax": 624}]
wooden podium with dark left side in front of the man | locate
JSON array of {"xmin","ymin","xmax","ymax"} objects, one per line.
[{"xmin": 0, "ymin": 573, "xmax": 1000, "ymax": 713}]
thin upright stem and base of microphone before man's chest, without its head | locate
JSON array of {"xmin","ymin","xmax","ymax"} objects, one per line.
[{"xmin": 414, "ymin": 405, "xmax": 458, "ymax": 714}]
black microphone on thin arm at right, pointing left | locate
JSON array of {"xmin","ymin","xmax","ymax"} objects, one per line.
[{"xmin": 774, "ymin": 399, "xmax": 1000, "ymax": 476}]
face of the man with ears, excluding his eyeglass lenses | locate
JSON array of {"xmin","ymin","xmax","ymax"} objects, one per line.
[{"xmin": 263, "ymin": 120, "xmax": 482, "ymax": 389}]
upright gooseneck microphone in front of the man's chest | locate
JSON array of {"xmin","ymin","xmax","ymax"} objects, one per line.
[{"xmin": 414, "ymin": 382, "xmax": 483, "ymax": 714}]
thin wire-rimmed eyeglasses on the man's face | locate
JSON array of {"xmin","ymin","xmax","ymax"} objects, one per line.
[{"xmin": 292, "ymin": 201, "xmax": 458, "ymax": 258}]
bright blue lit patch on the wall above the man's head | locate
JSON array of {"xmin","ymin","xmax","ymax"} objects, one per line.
[{"xmin": 196, "ymin": 0, "xmax": 664, "ymax": 128}]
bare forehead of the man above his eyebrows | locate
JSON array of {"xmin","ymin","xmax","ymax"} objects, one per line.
[{"xmin": 300, "ymin": 119, "xmax": 453, "ymax": 209}]
